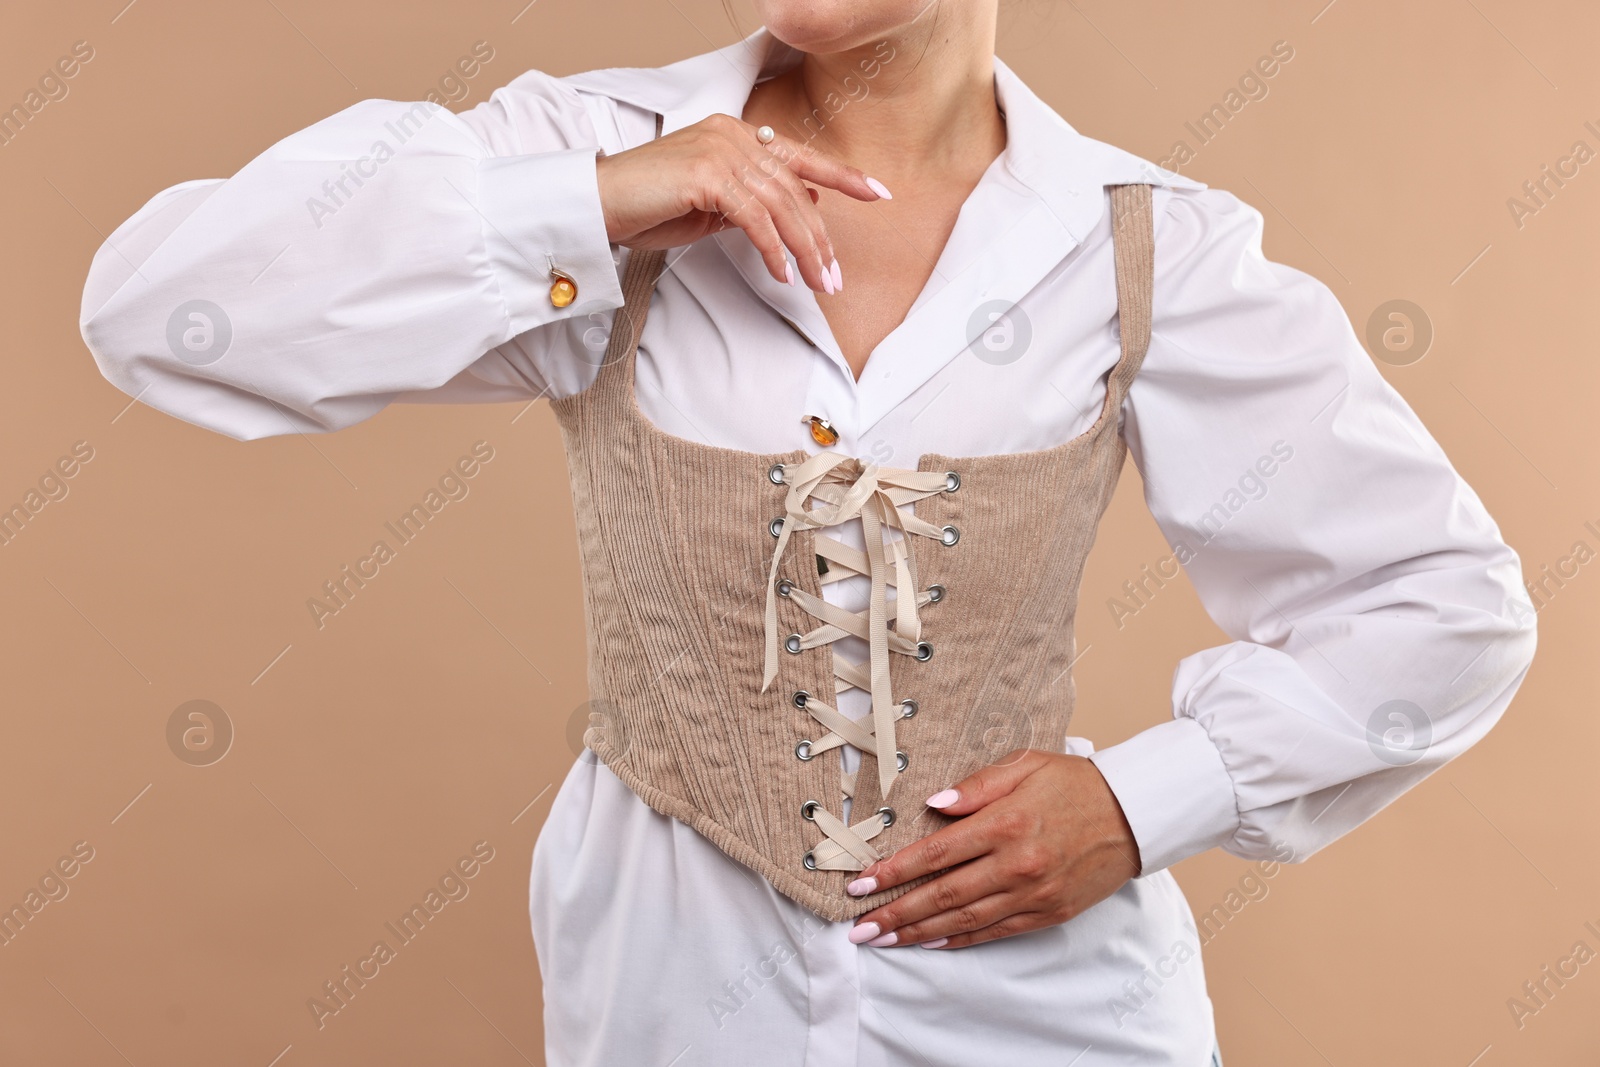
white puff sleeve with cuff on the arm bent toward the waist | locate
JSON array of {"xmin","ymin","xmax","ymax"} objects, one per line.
[{"xmin": 1091, "ymin": 189, "xmax": 1536, "ymax": 875}]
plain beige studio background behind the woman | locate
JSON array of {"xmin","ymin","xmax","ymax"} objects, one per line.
[{"xmin": 0, "ymin": 0, "xmax": 1600, "ymax": 1067}]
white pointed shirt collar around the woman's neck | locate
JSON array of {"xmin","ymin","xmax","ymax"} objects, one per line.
[{"xmin": 565, "ymin": 26, "xmax": 1205, "ymax": 241}]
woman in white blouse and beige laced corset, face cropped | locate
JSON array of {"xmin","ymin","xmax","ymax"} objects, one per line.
[{"xmin": 83, "ymin": 0, "xmax": 1534, "ymax": 1067}]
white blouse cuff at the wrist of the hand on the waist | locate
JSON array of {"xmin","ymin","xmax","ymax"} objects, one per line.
[{"xmin": 1090, "ymin": 717, "xmax": 1238, "ymax": 878}]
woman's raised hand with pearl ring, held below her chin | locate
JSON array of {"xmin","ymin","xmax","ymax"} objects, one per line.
[{"xmin": 595, "ymin": 115, "xmax": 885, "ymax": 293}]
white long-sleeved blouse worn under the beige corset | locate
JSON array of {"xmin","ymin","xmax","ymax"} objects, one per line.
[{"xmin": 82, "ymin": 30, "xmax": 1534, "ymax": 1067}]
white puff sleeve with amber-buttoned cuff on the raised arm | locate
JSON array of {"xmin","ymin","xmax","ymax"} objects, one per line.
[{"xmin": 80, "ymin": 70, "xmax": 622, "ymax": 440}]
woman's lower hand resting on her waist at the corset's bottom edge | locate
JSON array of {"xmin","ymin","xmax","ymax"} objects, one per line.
[{"xmin": 848, "ymin": 749, "xmax": 1139, "ymax": 949}]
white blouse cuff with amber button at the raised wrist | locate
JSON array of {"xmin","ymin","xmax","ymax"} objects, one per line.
[{"xmin": 478, "ymin": 147, "xmax": 622, "ymax": 336}]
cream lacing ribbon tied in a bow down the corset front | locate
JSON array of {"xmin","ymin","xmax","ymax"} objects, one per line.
[{"xmin": 762, "ymin": 451, "xmax": 957, "ymax": 870}]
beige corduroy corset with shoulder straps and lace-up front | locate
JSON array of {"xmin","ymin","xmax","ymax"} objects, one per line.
[{"xmin": 552, "ymin": 184, "xmax": 1154, "ymax": 921}]
